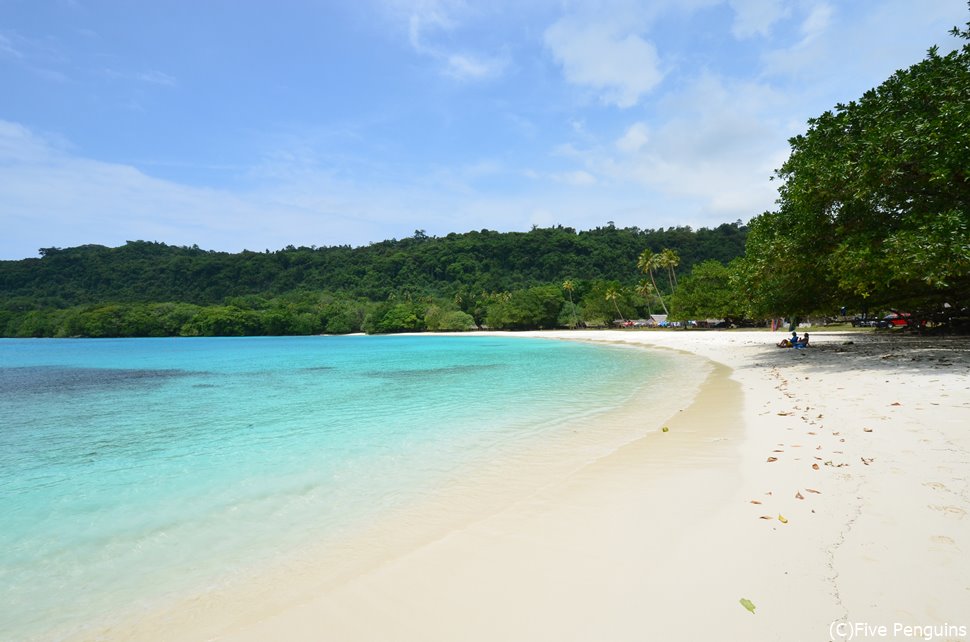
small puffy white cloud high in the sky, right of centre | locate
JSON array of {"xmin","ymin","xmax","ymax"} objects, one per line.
[{"xmin": 544, "ymin": 18, "xmax": 663, "ymax": 108}]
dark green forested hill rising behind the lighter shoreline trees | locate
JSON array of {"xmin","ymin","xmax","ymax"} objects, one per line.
[{"xmin": 0, "ymin": 221, "xmax": 747, "ymax": 310}]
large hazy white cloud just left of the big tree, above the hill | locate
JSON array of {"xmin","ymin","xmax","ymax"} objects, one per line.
[{"xmin": 561, "ymin": 75, "xmax": 792, "ymax": 222}]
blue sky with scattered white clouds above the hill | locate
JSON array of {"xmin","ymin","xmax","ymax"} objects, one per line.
[{"xmin": 0, "ymin": 0, "xmax": 970, "ymax": 260}]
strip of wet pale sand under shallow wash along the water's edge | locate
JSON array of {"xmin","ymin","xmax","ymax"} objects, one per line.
[{"xmin": 65, "ymin": 334, "xmax": 708, "ymax": 640}]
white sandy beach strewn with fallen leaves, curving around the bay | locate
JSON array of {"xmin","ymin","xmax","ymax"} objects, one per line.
[{"xmin": 85, "ymin": 331, "xmax": 970, "ymax": 642}]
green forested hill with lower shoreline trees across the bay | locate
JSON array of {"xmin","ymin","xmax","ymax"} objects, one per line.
[{"xmin": 0, "ymin": 222, "xmax": 746, "ymax": 337}]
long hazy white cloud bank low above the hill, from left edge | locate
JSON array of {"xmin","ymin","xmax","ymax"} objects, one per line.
[{"xmin": 0, "ymin": 120, "xmax": 602, "ymax": 259}]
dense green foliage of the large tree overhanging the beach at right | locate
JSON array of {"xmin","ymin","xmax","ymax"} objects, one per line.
[{"xmin": 739, "ymin": 20, "xmax": 970, "ymax": 316}]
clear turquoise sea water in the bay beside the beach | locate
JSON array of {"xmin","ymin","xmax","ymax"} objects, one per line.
[{"xmin": 0, "ymin": 336, "xmax": 670, "ymax": 639}]
